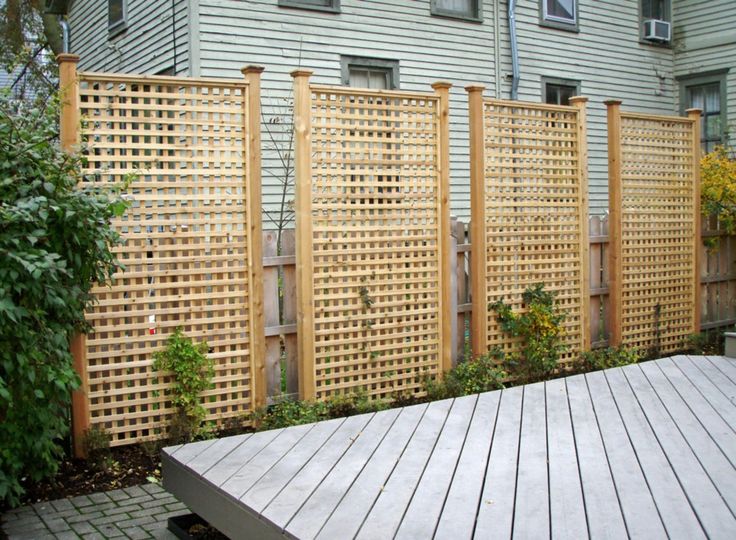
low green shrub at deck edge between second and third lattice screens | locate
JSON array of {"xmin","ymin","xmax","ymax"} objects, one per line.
[{"xmin": 424, "ymin": 353, "xmax": 508, "ymax": 401}]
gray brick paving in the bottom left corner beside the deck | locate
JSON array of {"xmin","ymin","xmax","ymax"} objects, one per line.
[{"xmin": 0, "ymin": 484, "xmax": 189, "ymax": 540}]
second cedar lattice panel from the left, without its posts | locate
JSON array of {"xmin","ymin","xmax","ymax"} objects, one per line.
[{"xmin": 311, "ymin": 86, "xmax": 441, "ymax": 398}]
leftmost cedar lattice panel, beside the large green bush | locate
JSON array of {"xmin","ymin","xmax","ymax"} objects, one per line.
[{"xmin": 80, "ymin": 74, "xmax": 252, "ymax": 445}]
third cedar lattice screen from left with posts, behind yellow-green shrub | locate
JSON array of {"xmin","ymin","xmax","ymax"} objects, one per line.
[{"xmin": 468, "ymin": 92, "xmax": 589, "ymax": 368}]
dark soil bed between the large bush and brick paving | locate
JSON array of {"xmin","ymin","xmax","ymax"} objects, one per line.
[{"xmin": 0, "ymin": 445, "xmax": 161, "ymax": 513}]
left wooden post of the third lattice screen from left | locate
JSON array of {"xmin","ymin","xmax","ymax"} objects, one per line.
[{"xmin": 465, "ymin": 85, "xmax": 488, "ymax": 357}]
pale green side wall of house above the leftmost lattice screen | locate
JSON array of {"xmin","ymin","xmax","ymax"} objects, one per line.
[{"xmin": 69, "ymin": 0, "xmax": 189, "ymax": 74}]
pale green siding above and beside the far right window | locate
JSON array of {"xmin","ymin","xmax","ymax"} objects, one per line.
[{"xmin": 674, "ymin": 0, "xmax": 736, "ymax": 149}]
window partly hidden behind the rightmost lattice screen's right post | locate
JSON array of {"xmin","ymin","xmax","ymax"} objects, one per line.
[{"xmin": 680, "ymin": 70, "xmax": 728, "ymax": 153}]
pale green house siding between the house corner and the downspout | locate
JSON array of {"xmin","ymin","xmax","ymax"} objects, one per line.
[{"xmin": 199, "ymin": 0, "xmax": 494, "ymax": 223}]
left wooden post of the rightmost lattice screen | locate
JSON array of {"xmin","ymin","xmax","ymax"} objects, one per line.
[{"xmin": 605, "ymin": 99, "xmax": 623, "ymax": 347}]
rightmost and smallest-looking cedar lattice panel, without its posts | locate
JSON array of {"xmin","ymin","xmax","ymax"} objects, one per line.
[{"xmin": 620, "ymin": 114, "xmax": 699, "ymax": 353}]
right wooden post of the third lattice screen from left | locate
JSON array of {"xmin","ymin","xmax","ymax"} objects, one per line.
[{"xmin": 570, "ymin": 96, "xmax": 590, "ymax": 351}]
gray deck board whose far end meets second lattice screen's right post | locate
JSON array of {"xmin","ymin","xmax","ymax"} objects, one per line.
[{"xmin": 357, "ymin": 400, "xmax": 454, "ymax": 539}]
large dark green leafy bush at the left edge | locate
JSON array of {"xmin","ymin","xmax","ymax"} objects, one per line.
[{"xmin": 0, "ymin": 92, "xmax": 125, "ymax": 505}]
